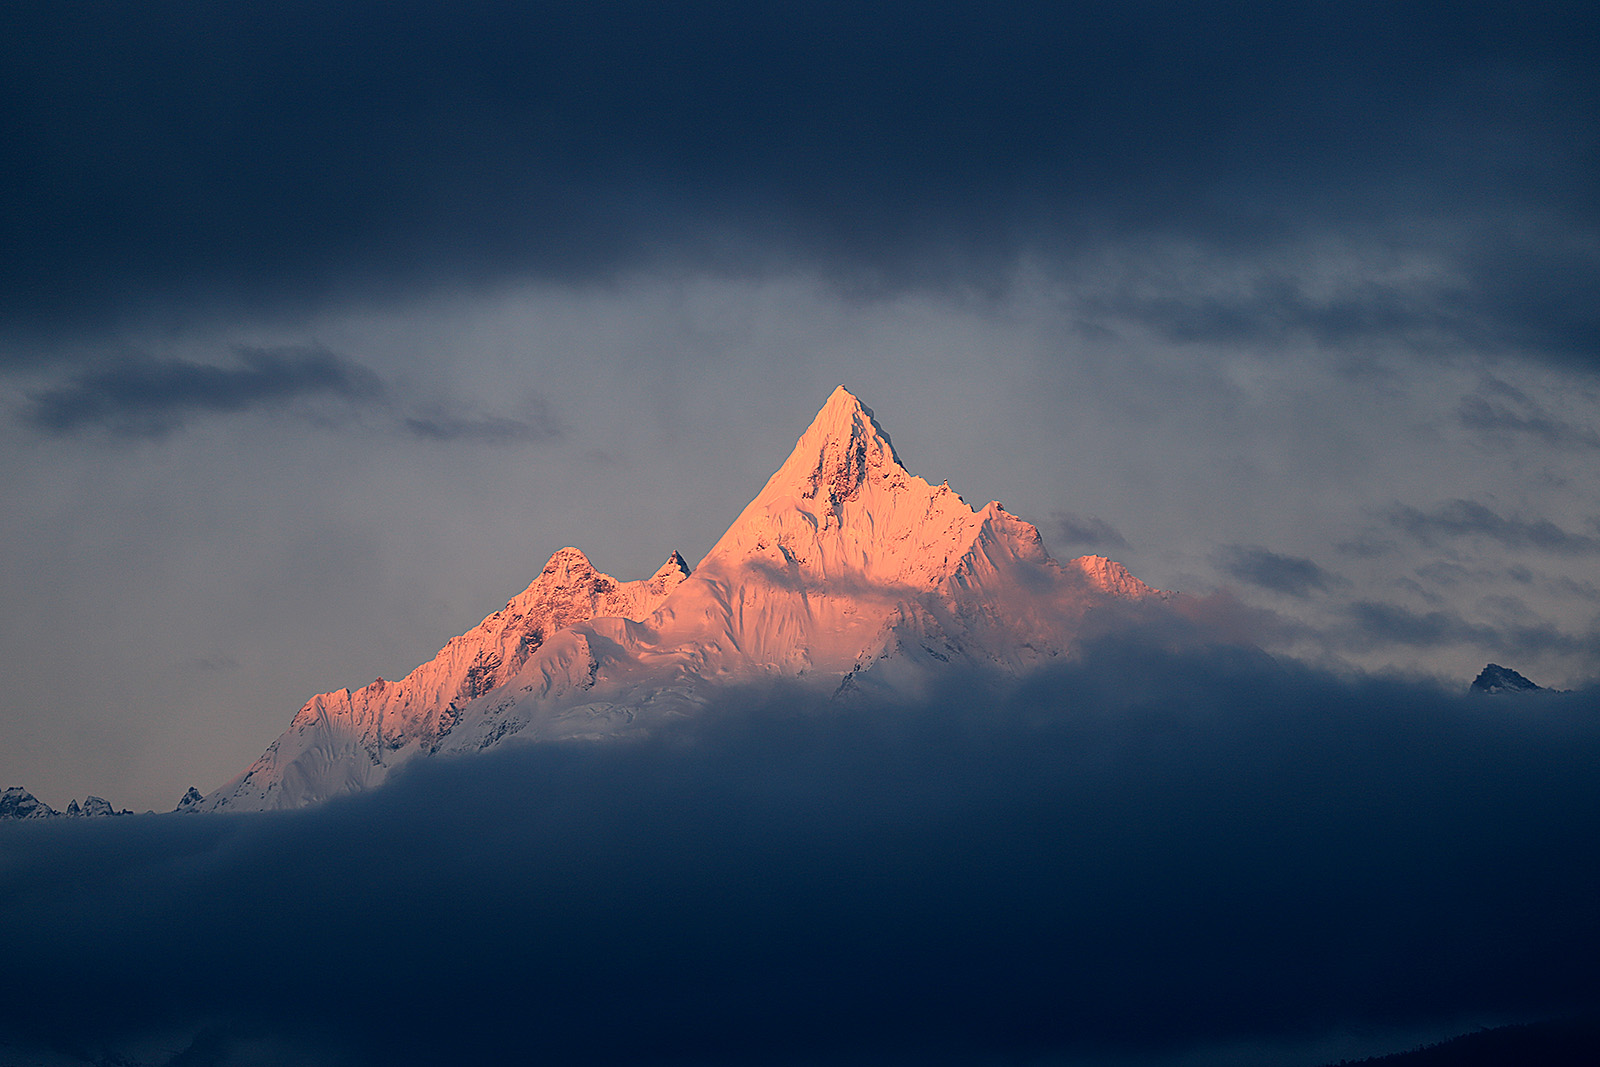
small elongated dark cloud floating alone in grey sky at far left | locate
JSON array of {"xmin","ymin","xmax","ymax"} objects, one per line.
[{"xmin": 22, "ymin": 347, "xmax": 384, "ymax": 438}]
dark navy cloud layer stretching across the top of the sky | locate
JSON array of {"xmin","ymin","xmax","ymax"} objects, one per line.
[{"xmin": 0, "ymin": 0, "xmax": 1600, "ymax": 366}]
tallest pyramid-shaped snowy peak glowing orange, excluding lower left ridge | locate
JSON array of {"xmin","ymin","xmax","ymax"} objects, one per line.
[{"xmin": 650, "ymin": 387, "xmax": 1154, "ymax": 675}]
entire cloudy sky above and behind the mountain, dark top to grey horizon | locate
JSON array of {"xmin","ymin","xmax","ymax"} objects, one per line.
[{"xmin": 0, "ymin": 0, "xmax": 1600, "ymax": 809}]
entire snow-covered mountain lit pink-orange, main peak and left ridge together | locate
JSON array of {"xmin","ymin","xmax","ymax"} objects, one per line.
[{"xmin": 200, "ymin": 387, "xmax": 1166, "ymax": 811}]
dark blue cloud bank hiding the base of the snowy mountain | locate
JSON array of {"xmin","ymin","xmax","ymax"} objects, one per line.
[{"xmin": 0, "ymin": 641, "xmax": 1600, "ymax": 1064}]
